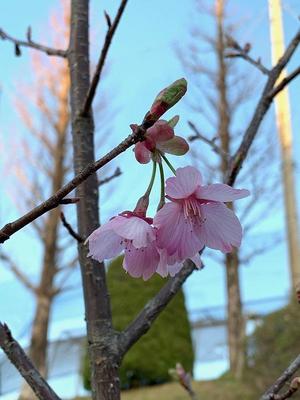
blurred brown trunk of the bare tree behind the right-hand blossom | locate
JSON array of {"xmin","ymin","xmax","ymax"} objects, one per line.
[{"xmin": 216, "ymin": 0, "xmax": 245, "ymax": 378}]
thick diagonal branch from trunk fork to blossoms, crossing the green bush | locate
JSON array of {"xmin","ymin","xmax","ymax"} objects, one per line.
[{"xmin": 119, "ymin": 260, "xmax": 195, "ymax": 356}]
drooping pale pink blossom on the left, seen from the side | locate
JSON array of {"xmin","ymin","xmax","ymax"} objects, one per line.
[{"xmin": 87, "ymin": 211, "xmax": 195, "ymax": 280}]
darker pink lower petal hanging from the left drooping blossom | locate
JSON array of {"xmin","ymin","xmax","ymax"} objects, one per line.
[{"xmin": 123, "ymin": 243, "xmax": 159, "ymax": 281}]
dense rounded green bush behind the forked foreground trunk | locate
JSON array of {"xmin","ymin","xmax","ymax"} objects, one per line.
[{"xmin": 83, "ymin": 257, "xmax": 193, "ymax": 389}]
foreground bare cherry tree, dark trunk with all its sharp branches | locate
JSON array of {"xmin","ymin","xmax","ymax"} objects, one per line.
[{"xmin": 0, "ymin": 0, "xmax": 300, "ymax": 400}]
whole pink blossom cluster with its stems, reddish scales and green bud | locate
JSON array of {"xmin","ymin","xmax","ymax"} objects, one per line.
[{"xmin": 87, "ymin": 80, "xmax": 249, "ymax": 280}]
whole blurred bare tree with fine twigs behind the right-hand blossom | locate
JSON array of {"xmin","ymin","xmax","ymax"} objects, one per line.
[{"xmin": 179, "ymin": 0, "xmax": 278, "ymax": 378}]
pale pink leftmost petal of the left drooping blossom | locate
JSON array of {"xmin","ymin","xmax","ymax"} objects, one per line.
[{"xmin": 87, "ymin": 221, "xmax": 124, "ymax": 262}]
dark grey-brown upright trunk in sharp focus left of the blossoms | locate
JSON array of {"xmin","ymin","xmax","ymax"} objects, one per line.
[{"xmin": 69, "ymin": 0, "xmax": 120, "ymax": 400}]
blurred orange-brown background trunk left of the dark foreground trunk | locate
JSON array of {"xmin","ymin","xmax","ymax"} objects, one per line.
[{"xmin": 19, "ymin": 59, "xmax": 70, "ymax": 400}]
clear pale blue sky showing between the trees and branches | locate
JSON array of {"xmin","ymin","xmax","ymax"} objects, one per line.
[{"xmin": 0, "ymin": 0, "xmax": 300, "ymax": 388}]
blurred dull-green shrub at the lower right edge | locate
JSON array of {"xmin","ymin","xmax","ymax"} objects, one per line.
[{"xmin": 245, "ymin": 303, "xmax": 300, "ymax": 392}]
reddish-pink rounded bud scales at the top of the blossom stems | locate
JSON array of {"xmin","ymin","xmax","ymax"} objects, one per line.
[{"xmin": 131, "ymin": 118, "xmax": 189, "ymax": 164}]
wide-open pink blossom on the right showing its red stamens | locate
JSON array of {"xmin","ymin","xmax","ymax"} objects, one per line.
[{"xmin": 154, "ymin": 167, "xmax": 249, "ymax": 260}]
